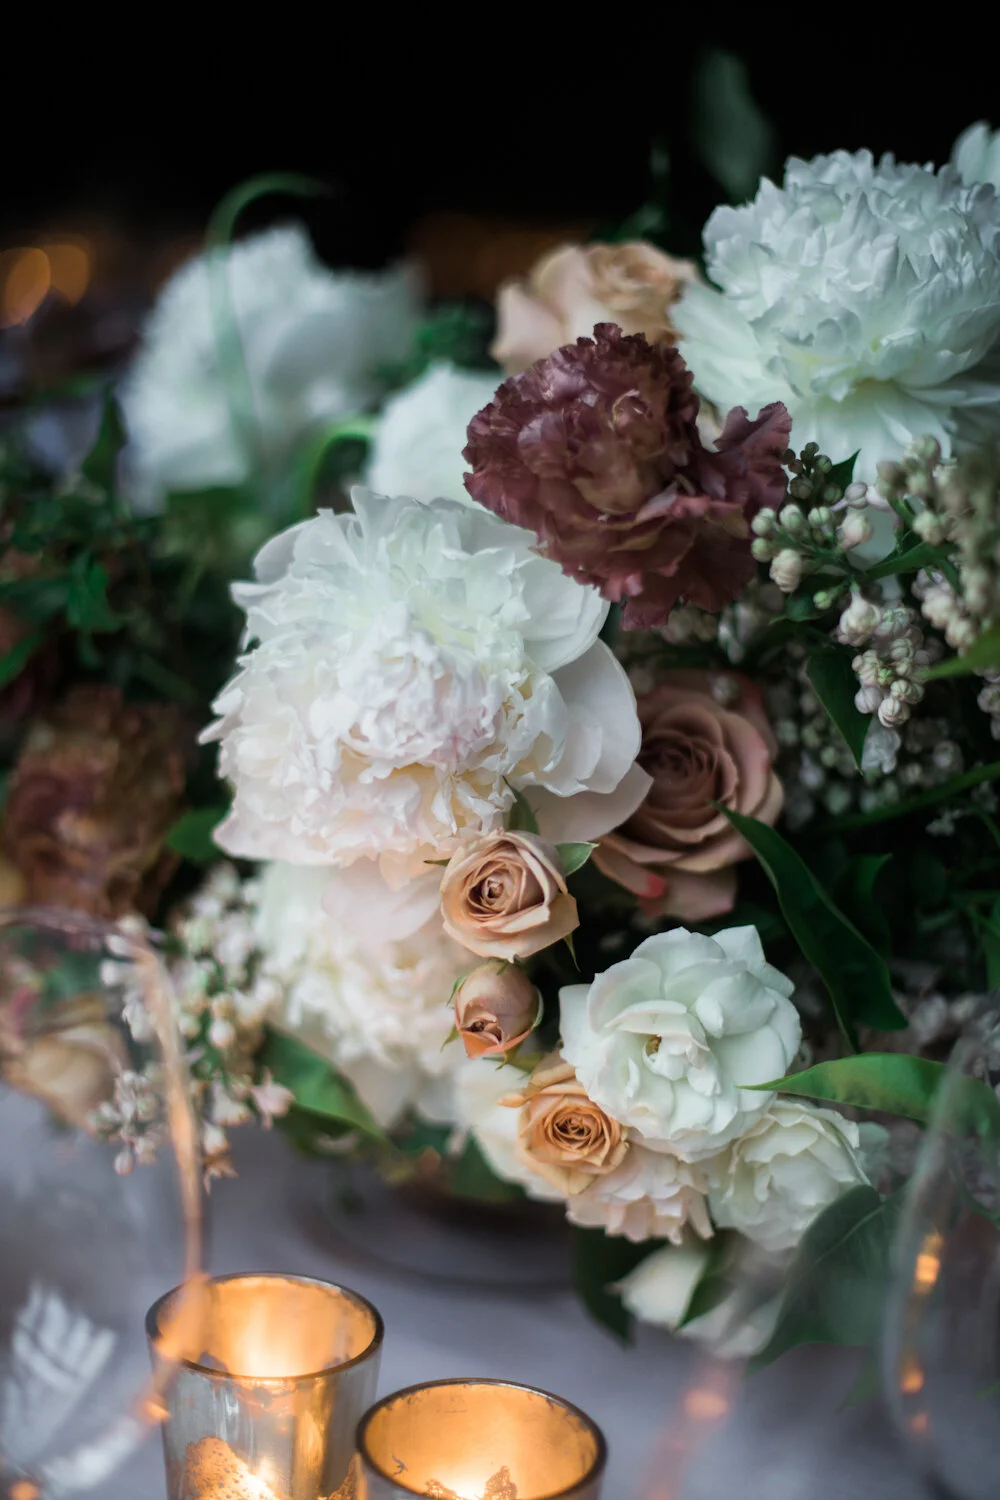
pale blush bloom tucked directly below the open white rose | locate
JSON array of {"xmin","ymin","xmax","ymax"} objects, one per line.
[{"xmin": 567, "ymin": 1140, "xmax": 712, "ymax": 1245}]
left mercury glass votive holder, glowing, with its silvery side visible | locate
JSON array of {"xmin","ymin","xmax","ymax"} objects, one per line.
[{"xmin": 147, "ymin": 1275, "xmax": 382, "ymax": 1500}]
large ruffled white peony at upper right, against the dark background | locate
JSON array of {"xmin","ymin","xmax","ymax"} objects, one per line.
[{"xmin": 673, "ymin": 152, "xmax": 1000, "ymax": 480}]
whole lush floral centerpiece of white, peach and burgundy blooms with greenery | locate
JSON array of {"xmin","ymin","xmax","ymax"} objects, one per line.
[{"xmin": 0, "ymin": 128, "xmax": 1000, "ymax": 1361}]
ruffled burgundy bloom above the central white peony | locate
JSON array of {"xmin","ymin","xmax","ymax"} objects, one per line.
[{"xmin": 465, "ymin": 323, "xmax": 792, "ymax": 627}]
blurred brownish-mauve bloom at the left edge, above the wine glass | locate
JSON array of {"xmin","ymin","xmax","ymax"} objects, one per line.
[{"xmin": 3, "ymin": 687, "xmax": 184, "ymax": 917}]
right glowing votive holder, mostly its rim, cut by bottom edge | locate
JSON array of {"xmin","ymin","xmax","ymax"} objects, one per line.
[{"xmin": 357, "ymin": 1380, "xmax": 607, "ymax": 1500}]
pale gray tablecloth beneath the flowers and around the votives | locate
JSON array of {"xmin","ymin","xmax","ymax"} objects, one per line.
[{"xmin": 7, "ymin": 1131, "xmax": 922, "ymax": 1500}]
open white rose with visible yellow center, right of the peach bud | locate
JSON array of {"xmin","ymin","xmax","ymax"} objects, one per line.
[{"xmin": 559, "ymin": 927, "xmax": 802, "ymax": 1161}]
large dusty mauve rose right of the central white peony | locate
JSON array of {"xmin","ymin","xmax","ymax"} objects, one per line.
[{"xmin": 594, "ymin": 672, "xmax": 784, "ymax": 921}]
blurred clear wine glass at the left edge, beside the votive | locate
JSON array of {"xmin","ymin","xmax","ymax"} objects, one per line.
[{"xmin": 0, "ymin": 909, "xmax": 201, "ymax": 1500}]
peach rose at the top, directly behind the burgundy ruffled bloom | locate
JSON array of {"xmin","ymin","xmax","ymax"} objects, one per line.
[{"xmin": 490, "ymin": 240, "xmax": 699, "ymax": 375}]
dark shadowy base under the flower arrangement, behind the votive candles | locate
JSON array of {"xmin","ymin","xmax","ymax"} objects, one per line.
[{"xmin": 325, "ymin": 1163, "xmax": 573, "ymax": 1290}]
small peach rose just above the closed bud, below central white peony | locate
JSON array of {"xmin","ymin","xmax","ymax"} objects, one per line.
[{"xmin": 441, "ymin": 833, "xmax": 580, "ymax": 959}]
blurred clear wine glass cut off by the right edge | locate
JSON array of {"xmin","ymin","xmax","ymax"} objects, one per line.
[{"xmin": 882, "ymin": 1001, "xmax": 1000, "ymax": 1500}]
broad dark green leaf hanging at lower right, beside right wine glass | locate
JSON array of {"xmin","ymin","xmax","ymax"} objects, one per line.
[{"xmin": 750, "ymin": 1187, "xmax": 903, "ymax": 1370}]
